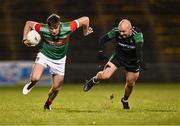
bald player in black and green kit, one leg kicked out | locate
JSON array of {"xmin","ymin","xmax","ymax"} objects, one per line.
[{"xmin": 83, "ymin": 19, "xmax": 145, "ymax": 109}]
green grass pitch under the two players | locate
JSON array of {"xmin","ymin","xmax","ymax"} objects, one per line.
[{"xmin": 0, "ymin": 83, "xmax": 180, "ymax": 125}]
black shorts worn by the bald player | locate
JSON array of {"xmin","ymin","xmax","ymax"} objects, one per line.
[{"xmin": 109, "ymin": 53, "xmax": 140, "ymax": 73}]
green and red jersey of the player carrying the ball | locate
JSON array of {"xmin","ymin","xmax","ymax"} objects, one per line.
[{"xmin": 35, "ymin": 21, "xmax": 77, "ymax": 60}]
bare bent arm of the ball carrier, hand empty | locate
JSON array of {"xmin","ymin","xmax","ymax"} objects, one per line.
[{"xmin": 77, "ymin": 16, "xmax": 93, "ymax": 36}]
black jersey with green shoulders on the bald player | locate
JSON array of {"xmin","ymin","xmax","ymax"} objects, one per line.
[{"xmin": 107, "ymin": 27, "xmax": 144, "ymax": 61}]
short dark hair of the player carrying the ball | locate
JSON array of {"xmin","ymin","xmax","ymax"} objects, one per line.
[{"xmin": 47, "ymin": 14, "xmax": 60, "ymax": 27}]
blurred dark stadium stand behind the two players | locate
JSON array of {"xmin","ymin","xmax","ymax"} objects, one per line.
[{"xmin": 0, "ymin": 0, "xmax": 180, "ymax": 82}]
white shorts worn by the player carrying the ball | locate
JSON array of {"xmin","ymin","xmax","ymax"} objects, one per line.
[{"xmin": 35, "ymin": 52, "xmax": 66, "ymax": 76}]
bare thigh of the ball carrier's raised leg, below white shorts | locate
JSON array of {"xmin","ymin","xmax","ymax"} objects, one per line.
[{"xmin": 31, "ymin": 63, "xmax": 44, "ymax": 80}]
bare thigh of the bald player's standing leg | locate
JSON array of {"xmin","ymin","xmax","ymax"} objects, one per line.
[{"xmin": 126, "ymin": 72, "xmax": 139, "ymax": 84}]
